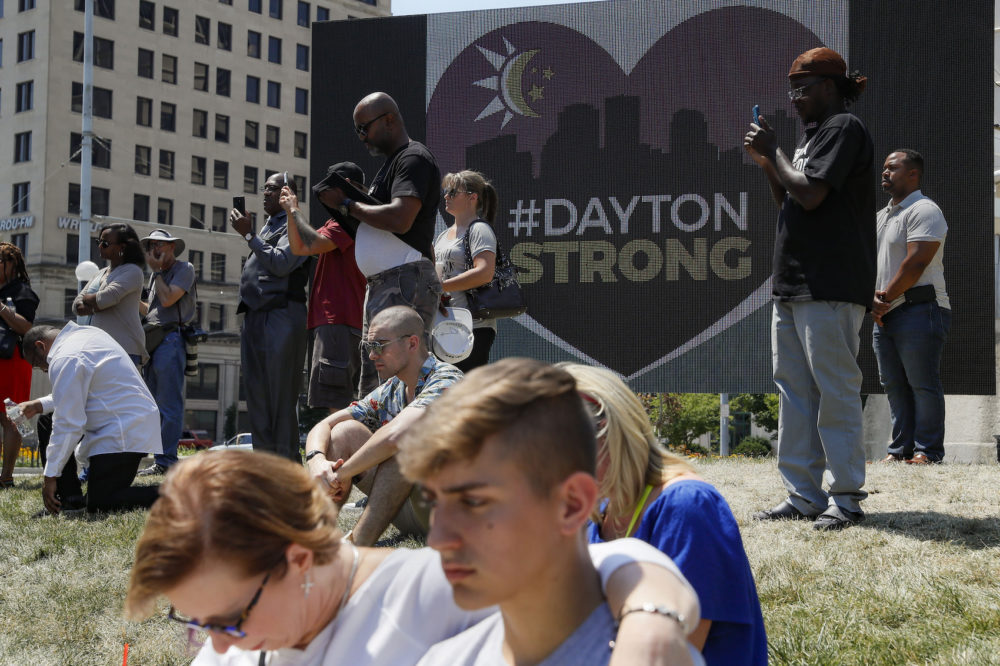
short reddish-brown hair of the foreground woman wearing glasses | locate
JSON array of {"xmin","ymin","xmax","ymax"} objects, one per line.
[{"xmin": 125, "ymin": 451, "xmax": 343, "ymax": 619}]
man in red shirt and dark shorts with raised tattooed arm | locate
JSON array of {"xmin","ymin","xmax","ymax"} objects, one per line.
[{"xmin": 280, "ymin": 162, "xmax": 366, "ymax": 414}]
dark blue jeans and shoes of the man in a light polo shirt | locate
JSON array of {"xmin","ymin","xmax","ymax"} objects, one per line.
[{"xmin": 872, "ymin": 301, "xmax": 951, "ymax": 462}]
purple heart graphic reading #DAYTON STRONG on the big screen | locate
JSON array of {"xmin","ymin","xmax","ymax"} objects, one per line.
[{"xmin": 427, "ymin": 7, "xmax": 820, "ymax": 375}]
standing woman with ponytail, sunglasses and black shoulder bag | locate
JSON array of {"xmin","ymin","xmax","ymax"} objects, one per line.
[{"xmin": 434, "ymin": 171, "xmax": 497, "ymax": 372}]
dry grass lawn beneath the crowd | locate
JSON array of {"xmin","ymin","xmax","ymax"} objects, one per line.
[{"xmin": 0, "ymin": 459, "xmax": 1000, "ymax": 666}]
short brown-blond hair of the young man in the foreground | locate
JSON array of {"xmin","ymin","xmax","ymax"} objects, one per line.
[{"xmin": 397, "ymin": 358, "xmax": 597, "ymax": 497}]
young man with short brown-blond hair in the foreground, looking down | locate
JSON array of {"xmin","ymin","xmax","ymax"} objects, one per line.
[{"xmin": 399, "ymin": 359, "xmax": 700, "ymax": 666}]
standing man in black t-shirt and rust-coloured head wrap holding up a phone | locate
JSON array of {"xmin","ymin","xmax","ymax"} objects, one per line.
[{"xmin": 744, "ymin": 48, "xmax": 875, "ymax": 530}]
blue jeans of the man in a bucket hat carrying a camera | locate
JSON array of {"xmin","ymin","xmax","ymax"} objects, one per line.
[{"xmin": 143, "ymin": 330, "xmax": 187, "ymax": 467}]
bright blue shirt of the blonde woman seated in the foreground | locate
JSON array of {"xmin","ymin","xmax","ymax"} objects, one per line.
[{"xmin": 587, "ymin": 479, "xmax": 767, "ymax": 666}]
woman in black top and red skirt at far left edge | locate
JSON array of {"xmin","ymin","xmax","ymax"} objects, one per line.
[{"xmin": 0, "ymin": 243, "xmax": 38, "ymax": 490}]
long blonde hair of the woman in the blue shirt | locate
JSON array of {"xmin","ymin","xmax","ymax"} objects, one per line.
[{"xmin": 559, "ymin": 363, "xmax": 693, "ymax": 516}]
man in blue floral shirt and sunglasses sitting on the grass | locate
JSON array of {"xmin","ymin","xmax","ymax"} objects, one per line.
[{"xmin": 306, "ymin": 305, "xmax": 462, "ymax": 546}]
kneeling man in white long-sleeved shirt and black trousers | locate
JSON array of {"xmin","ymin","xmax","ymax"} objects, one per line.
[{"xmin": 20, "ymin": 322, "xmax": 162, "ymax": 514}]
